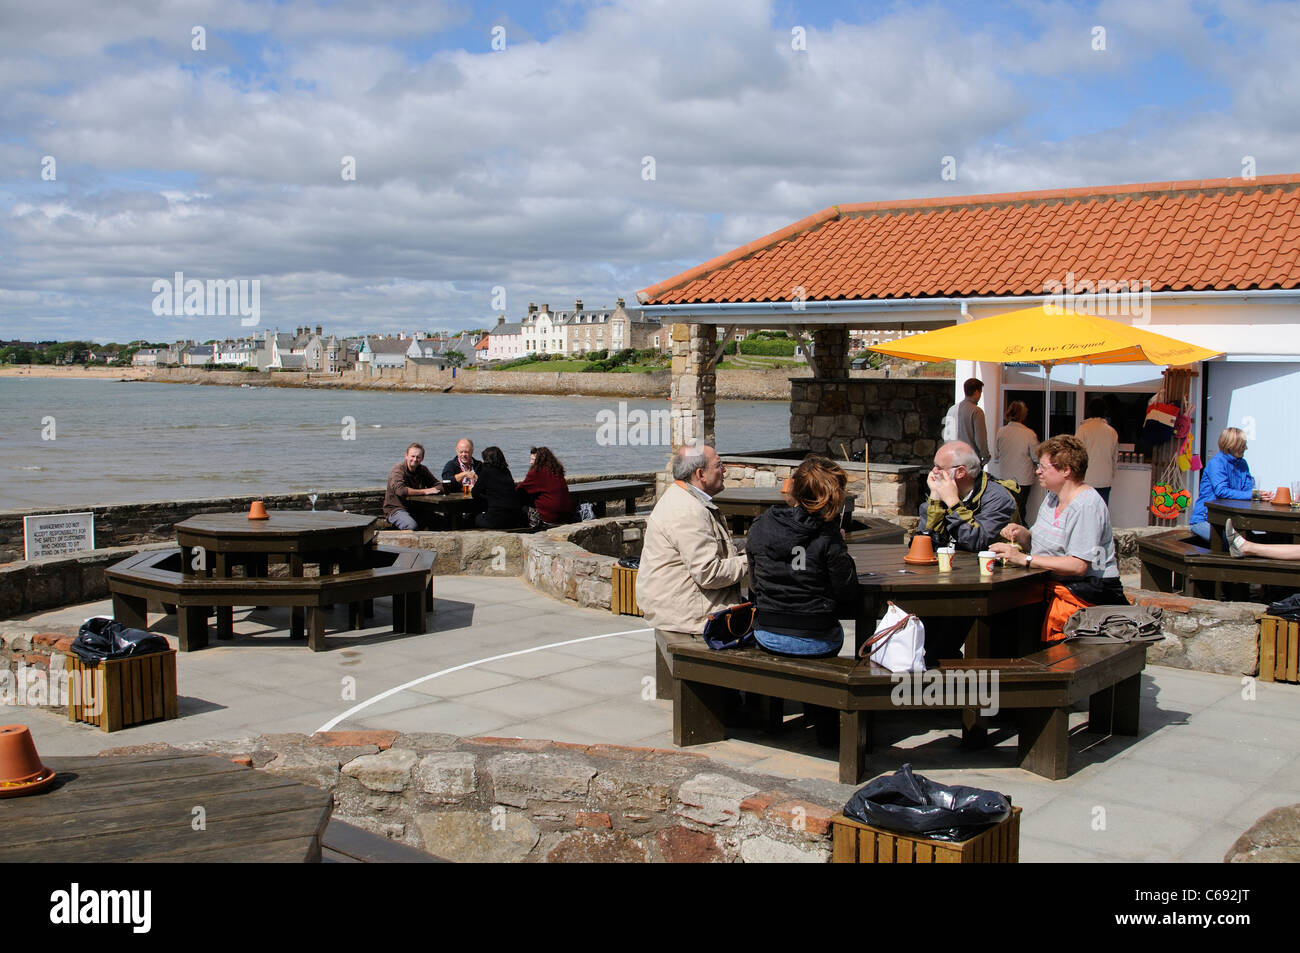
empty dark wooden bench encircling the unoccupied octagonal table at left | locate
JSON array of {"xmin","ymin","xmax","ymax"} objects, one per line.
[{"xmin": 105, "ymin": 546, "xmax": 434, "ymax": 651}]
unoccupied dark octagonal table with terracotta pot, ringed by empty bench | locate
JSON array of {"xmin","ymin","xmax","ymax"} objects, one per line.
[{"xmin": 176, "ymin": 510, "xmax": 376, "ymax": 638}]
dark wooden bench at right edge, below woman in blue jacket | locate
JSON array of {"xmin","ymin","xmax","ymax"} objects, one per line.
[{"xmin": 1138, "ymin": 529, "xmax": 1300, "ymax": 599}]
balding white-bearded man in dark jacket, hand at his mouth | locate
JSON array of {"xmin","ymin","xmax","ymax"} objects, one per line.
[{"xmin": 919, "ymin": 441, "xmax": 1021, "ymax": 553}]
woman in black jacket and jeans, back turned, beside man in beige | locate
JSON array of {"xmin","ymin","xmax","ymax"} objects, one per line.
[{"xmin": 745, "ymin": 455, "xmax": 858, "ymax": 655}]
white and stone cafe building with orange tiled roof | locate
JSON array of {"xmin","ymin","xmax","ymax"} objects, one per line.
[{"xmin": 638, "ymin": 176, "xmax": 1300, "ymax": 525}]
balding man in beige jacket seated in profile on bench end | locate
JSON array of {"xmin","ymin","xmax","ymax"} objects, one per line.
[{"xmin": 637, "ymin": 446, "xmax": 749, "ymax": 636}]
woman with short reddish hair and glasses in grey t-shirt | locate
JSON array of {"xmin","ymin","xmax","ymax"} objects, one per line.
[{"xmin": 992, "ymin": 436, "xmax": 1128, "ymax": 642}]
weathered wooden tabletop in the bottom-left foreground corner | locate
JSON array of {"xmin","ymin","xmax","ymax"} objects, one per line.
[{"xmin": 0, "ymin": 754, "xmax": 334, "ymax": 863}]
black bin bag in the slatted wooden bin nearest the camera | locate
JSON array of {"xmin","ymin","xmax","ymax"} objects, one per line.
[{"xmin": 844, "ymin": 764, "xmax": 1011, "ymax": 841}]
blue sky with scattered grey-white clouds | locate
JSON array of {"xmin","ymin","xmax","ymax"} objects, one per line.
[{"xmin": 0, "ymin": 0, "xmax": 1300, "ymax": 342}]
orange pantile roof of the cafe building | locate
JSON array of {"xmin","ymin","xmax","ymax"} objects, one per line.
[{"xmin": 637, "ymin": 176, "xmax": 1300, "ymax": 304}]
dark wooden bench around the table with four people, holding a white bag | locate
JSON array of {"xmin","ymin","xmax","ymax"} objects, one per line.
[{"xmin": 657, "ymin": 633, "xmax": 1147, "ymax": 784}]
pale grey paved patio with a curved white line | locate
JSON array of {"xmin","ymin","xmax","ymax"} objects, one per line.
[{"xmin": 12, "ymin": 576, "xmax": 1300, "ymax": 862}]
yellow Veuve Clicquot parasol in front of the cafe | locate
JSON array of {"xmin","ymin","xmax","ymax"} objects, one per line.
[{"xmin": 867, "ymin": 306, "xmax": 1222, "ymax": 430}]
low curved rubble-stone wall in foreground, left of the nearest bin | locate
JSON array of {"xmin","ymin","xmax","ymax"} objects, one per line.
[{"xmin": 94, "ymin": 731, "xmax": 852, "ymax": 863}]
